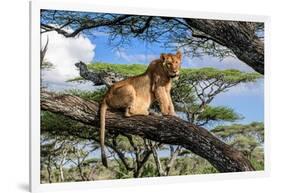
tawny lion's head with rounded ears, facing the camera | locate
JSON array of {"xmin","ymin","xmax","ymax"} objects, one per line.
[{"xmin": 160, "ymin": 51, "xmax": 182, "ymax": 78}]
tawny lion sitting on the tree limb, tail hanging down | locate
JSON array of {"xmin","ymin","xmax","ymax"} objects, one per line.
[{"xmin": 100, "ymin": 51, "xmax": 182, "ymax": 167}]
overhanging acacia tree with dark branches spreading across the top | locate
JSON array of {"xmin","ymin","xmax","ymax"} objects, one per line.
[{"xmin": 41, "ymin": 10, "xmax": 264, "ymax": 74}]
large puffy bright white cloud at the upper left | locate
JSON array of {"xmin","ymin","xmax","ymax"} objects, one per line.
[{"xmin": 41, "ymin": 29, "xmax": 95, "ymax": 83}]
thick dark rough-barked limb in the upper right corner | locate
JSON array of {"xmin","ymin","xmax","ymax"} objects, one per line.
[{"xmin": 185, "ymin": 18, "xmax": 264, "ymax": 74}]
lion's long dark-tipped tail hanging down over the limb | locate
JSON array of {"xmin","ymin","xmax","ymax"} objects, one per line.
[{"xmin": 100, "ymin": 101, "xmax": 108, "ymax": 167}]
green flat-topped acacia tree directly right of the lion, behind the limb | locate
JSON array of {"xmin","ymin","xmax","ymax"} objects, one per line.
[{"xmin": 172, "ymin": 68, "xmax": 261, "ymax": 126}]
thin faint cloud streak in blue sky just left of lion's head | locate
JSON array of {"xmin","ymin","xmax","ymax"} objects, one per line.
[{"xmin": 115, "ymin": 49, "xmax": 159, "ymax": 64}]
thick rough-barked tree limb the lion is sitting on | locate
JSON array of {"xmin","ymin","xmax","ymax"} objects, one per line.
[{"xmin": 41, "ymin": 91, "xmax": 254, "ymax": 172}]
